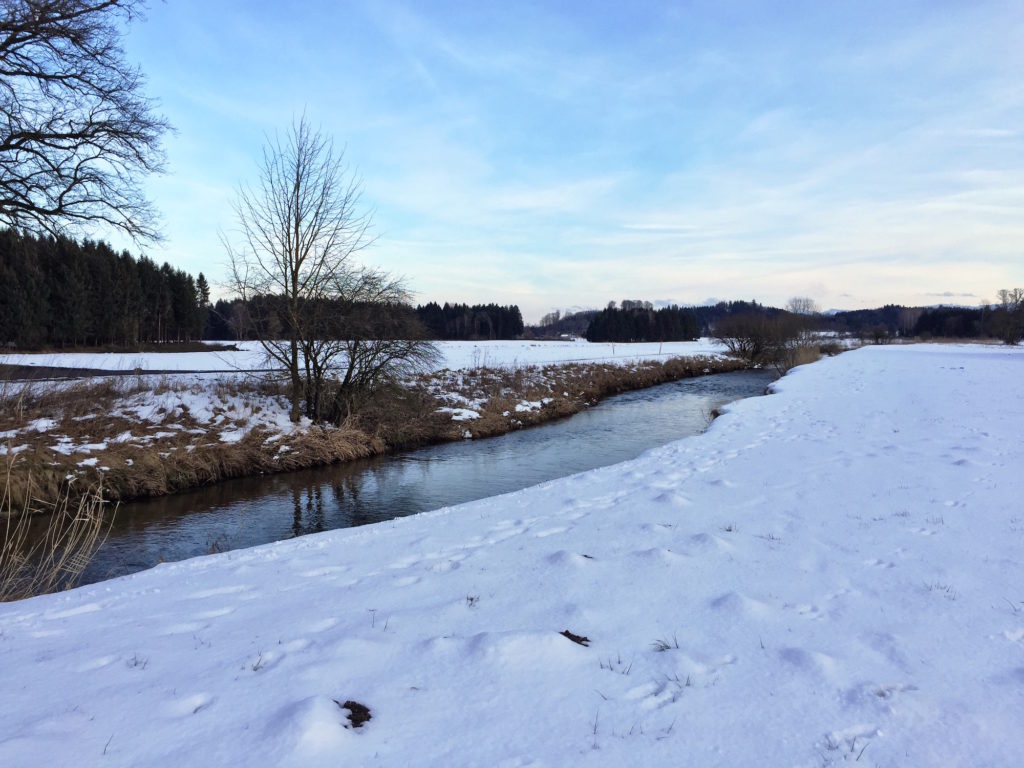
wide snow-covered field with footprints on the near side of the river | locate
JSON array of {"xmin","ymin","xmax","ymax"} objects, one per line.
[{"xmin": 0, "ymin": 345, "xmax": 1024, "ymax": 768}]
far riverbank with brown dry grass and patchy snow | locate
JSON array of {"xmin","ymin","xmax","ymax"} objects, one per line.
[{"xmin": 0, "ymin": 345, "xmax": 744, "ymax": 510}]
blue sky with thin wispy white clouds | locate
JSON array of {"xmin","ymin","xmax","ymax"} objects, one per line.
[{"xmin": 126, "ymin": 0, "xmax": 1024, "ymax": 321}]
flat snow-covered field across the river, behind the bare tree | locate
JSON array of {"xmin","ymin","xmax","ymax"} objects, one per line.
[{"xmin": 0, "ymin": 339, "xmax": 724, "ymax": 373}]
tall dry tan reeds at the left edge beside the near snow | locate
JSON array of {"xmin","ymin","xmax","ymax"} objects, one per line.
[{"xmin": 0, "ymin": 462, "xmax": 113, "ymax": 602}]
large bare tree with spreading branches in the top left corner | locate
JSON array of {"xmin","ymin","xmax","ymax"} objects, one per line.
[{"xmin": 0, "ymin": 0, "xmax": 170, "ymax": 242}]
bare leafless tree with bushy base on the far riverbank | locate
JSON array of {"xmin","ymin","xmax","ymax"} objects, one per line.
[{"xmin": 224, "ymin": 117, "xmax": 434, "ymax": 421}]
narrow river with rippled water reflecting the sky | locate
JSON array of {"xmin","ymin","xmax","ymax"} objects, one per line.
[{"xmin": 82, "ymin": 371, "xmax": 774, "ymax": 584}]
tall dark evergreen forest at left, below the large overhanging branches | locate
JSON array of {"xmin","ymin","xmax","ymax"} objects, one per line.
[{"xmin": 0, "ymin": 228, "xmax": 210, "ymax": 349}]
